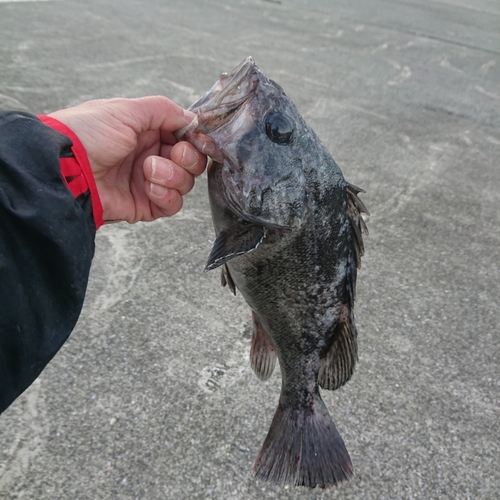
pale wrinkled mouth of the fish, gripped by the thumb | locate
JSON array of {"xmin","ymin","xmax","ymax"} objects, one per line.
[{"xmin": 174, "ymin": 56, "xmax": 261, "ymax": 140}]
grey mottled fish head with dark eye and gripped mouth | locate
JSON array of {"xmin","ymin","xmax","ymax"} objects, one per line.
[{"xmin": 176, "ymin": 57, "xmax": 320, "ymax": 228}]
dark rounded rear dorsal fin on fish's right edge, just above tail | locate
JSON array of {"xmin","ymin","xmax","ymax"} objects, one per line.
[{"xmin": 318, "ymin": 304, "xmax": 358, "ymax": 391}]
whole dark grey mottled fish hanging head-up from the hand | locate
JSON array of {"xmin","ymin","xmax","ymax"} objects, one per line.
[{"xmin": 175, "ymin": 57, "xmax": 368, "ymax": 488}]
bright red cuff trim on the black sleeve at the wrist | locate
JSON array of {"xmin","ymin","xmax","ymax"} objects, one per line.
[{"xmin": 38, "ymin": 115, "xmax": 104, "ymax": 229}]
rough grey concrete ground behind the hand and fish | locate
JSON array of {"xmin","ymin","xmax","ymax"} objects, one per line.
[{"xmin": 0, "ymin": 0, "xmax": 500, "ymax": 500}]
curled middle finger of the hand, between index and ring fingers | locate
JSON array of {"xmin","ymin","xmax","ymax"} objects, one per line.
[{"xmin": 143, "ymin": 156, "xmax": 194, "ymax": 197}]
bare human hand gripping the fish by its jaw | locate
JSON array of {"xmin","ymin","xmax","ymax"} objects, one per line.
[{"xmin": 50, "ymin": 96, "xmax": 206, "ymax": 223}]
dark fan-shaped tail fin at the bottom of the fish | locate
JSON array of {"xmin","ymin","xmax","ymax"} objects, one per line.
[{"xmin": 253, "ymin": 393, "xmax": 353, "ymax": 488}]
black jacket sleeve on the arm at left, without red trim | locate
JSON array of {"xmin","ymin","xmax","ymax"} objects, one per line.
[{"xmin": 0, "ymin": 111, "xmax": 96, "ymax": 413}]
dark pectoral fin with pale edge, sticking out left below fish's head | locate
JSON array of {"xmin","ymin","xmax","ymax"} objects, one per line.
[{"xmin": 205, "ymin": 224, "xmax": 266, "ymax": 271}]
